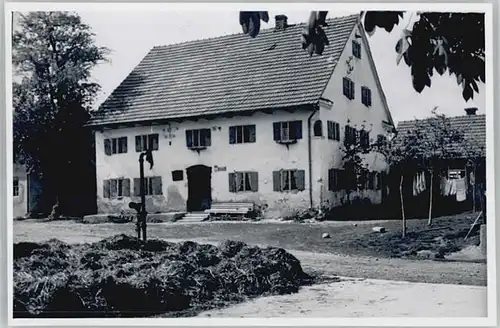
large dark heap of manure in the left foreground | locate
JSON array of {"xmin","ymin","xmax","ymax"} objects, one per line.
[{"xmin": 14, "ymin": 235, "xmax": 312, "ymax": 318}]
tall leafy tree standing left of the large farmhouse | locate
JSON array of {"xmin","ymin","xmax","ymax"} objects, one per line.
[{"xmin": 12, "ymin": 12, "xmax": 108, "ymax": 217}]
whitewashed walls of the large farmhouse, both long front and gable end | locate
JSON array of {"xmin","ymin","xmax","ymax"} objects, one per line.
[{"xmin": 95, "ymin": 21, "xmax": 396, "ymax": 217}]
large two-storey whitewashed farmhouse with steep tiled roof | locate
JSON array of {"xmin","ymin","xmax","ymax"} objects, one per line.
[{"xmin": 88, "ymin": 15, "xmax": 394, "ymax": 216}]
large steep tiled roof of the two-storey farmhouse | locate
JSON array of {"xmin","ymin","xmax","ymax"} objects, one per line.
[{"xmin": 89, "ymin": 15, "xmax": 358, "ymax": 125}]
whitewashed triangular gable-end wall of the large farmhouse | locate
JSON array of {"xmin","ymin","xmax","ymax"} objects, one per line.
[{"xmin": 313, "ymin": 23, "xmax": 390, "ymax": 206}]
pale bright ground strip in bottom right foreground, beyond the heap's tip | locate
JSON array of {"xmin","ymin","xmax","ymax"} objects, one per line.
[{"xmin": 199, "ymin": 279, "xmax": 487, "ymax": 318}]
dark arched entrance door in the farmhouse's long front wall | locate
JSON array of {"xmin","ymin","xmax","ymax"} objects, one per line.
[{"xmin": 186, "ymin": 165, "xmax": 212, "ymax": 212}]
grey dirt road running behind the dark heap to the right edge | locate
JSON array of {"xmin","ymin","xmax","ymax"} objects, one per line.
[{"xmin": 14, "ymin": 221, "xmax": 486, "ymax": 286}]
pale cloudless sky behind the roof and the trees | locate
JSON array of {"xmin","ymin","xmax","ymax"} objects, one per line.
[{"xmin": 26, "ymin": 8, "xmax": 485, "ymax": 122}]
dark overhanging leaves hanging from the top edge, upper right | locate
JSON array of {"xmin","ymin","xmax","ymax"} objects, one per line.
[{"xmin": 240, "ymin": 11, "xmax": 486, "ymax": 101}]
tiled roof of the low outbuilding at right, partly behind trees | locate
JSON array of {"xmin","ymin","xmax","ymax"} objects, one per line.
[{"xmin": 396, "ymin": 115, "xmax": 486, "ymax": 157}]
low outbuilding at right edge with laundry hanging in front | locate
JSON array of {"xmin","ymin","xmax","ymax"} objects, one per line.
[{"xmin": 390, "ymin": 108, "xmax": 486, "ymax": 216}]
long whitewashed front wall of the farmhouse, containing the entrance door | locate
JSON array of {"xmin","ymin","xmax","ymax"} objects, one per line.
[{"xmin": 95, "ymin": 111, "xmax": 311, "ymax": 216}]
